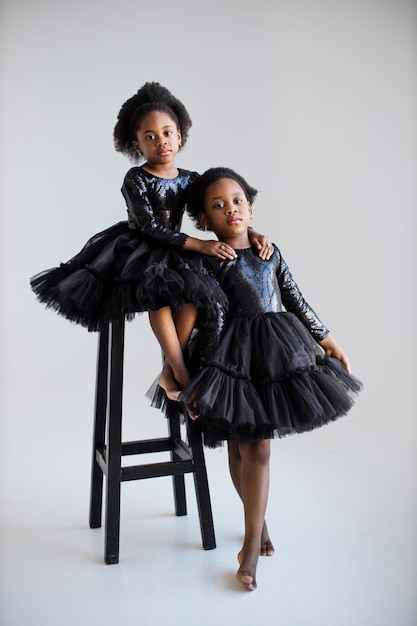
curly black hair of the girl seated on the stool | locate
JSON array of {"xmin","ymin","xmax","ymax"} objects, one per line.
[{"xmin": 113, "ymin": 82, "xmax": 192, "ymax": 163}]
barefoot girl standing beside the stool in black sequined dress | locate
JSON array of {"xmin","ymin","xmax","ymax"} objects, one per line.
[{"xmin": 180, "ymin": 168, "xmax": 361, "ymax": 591}]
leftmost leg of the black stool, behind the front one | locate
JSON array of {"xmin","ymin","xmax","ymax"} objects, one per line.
[{"xmin": 90, "ymin": 325, "xmax": 109, "ymax": 528}]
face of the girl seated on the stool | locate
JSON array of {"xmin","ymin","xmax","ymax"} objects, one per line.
[{"xmin": 133, "ymin": 111, "xmax": 181, "ymax": 166}]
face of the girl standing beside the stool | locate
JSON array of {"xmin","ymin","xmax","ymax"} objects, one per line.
[{"xmin": 200, "ymin": 178, "xmax": 252, "ymax": 241}]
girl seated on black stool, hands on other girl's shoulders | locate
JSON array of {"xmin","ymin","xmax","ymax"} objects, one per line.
[{"xmin": 31, "ymin": 82, "xmax": 269, "ymax": 399}]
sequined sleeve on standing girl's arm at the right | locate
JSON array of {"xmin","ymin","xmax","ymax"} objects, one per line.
[{"xmin": 277, "ymin": 250, "xmax": 329, "ymax": 341}]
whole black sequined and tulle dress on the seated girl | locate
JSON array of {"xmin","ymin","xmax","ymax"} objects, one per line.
[{"xmin": 30, "ymin": 167, "xmax": 226, "ymax": 331}]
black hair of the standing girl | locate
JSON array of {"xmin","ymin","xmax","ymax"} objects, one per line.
[{"xmin": 186, "ymin": 167, "xmax": 258, "ymax": 230}]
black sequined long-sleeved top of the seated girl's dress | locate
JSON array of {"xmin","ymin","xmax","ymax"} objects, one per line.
[{"xmin": 122, "ymin": 168, "xmax": 189, "ymax": 249}]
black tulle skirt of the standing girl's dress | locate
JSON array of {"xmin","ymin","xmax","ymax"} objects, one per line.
[{"xmin": 181, "ymin": 312, "xmax": 362, "ymax": 447}]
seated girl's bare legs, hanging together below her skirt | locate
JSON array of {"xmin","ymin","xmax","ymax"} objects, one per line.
[{"xmin": 149, "ymin": 304, "xmax": 197, "ymax": 400}]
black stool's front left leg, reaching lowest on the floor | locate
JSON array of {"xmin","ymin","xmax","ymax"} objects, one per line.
[{"xmin": 104, "ymin": 320, "xmax": 125, "ymax": 564}]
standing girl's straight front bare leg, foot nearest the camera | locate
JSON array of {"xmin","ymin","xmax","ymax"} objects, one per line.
[{"xmin": 229, "ymin": 439, "xmax": 270, "ymax": 591}]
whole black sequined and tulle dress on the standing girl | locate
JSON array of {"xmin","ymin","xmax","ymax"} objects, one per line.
[{"xmin": 181, "ymin": 246, "xmax": 362, "ymax": 447}]
